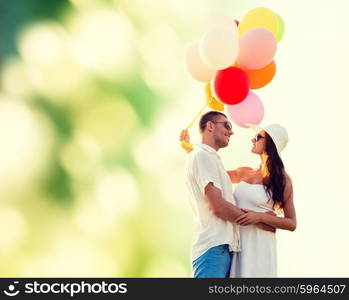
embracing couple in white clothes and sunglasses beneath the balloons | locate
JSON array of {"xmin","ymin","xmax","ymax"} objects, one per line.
[{"xmin": 180, "ymin": 111, "xmax": 297, "ymax": 278}]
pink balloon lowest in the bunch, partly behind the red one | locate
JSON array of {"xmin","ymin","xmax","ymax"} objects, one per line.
[{"xmin": 226, "ymin": 91, "xmax": 264, "ymax": 128}]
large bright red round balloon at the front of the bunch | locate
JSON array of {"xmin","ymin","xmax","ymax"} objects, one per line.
[{"xmin": 212, "ymin": 67, "xmax": 250, "ymax": 105}]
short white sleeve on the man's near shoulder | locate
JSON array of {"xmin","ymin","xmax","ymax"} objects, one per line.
[{"xmin": 194, "ymin": 151, "xmax": 222, "ymax": 194}]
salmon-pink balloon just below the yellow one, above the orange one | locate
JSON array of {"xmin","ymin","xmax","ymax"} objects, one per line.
[{"xmin": 236, "ymin": 27, "xmax": 276, "ymax": 70}]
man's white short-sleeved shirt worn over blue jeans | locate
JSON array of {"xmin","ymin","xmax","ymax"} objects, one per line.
[{"xmin": 186, "ymin": 144, "xmax": 240, "ymax": 260}]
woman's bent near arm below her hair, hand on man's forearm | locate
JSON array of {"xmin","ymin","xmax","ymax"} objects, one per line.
[{"xmin": 235, "ymin": 176, "xmax": 297, "ymax": 231}]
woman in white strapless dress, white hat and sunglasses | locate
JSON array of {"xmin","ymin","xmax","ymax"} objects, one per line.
[{"xmin": 180, "ymin": 124, "xmax": 297, "ymax": 277}]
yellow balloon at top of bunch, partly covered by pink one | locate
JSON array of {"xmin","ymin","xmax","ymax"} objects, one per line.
[{"xmin": 238, "ymin": 7, "xmax": 278, "ymax": 37}]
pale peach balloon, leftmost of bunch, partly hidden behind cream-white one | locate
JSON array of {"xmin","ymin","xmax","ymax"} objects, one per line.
[{"xmin": 185, "ymin": 43, "xmax": 215, "ymax": 82}]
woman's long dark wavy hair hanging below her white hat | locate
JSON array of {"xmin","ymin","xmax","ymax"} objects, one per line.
[{"xmin": 263, "ymin": 133, "xmax": 286, "ymax": 209}]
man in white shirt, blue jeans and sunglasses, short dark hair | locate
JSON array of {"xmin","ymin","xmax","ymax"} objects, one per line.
[{"xmin": 182, "ymin": 111, "xmax": 272, "ymax": 278}]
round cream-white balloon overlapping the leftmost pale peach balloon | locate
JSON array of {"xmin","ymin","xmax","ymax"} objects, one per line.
[{"xmin": 200, "ymin": 29, "xmax": 239, "ymax": 70}]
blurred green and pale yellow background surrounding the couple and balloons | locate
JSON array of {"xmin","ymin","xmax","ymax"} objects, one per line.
[{"xmin": 0, "ymin": 0, "xmax": 349, "ymax": 277}]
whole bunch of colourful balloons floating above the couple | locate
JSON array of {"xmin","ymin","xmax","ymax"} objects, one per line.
[{"xmin": 186, "ymin": 7, "xmax": 284, "ymax": 128}]
